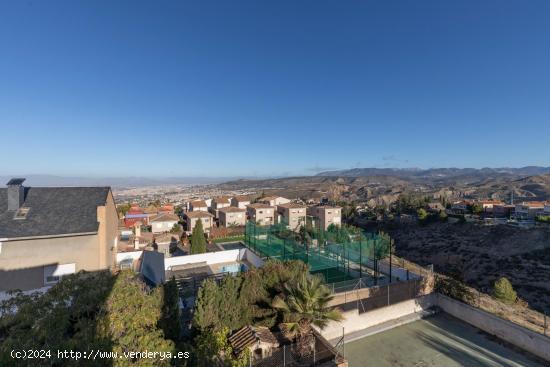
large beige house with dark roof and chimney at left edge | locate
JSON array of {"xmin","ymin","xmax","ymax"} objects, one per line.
[{"xmin": 0, "ymin": 178, "xmax": 118, "ymax": 291}]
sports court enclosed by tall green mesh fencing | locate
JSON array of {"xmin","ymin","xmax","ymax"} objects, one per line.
[{"xmin": 245, "ymin": 221, "xmax": 391, "ymax": 283}]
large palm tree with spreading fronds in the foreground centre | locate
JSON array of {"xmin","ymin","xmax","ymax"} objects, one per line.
[{"xmin": 272, "ymin": 273, "xmax": 343, "ymax": 356}]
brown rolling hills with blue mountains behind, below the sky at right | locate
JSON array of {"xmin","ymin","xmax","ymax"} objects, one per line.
[{"xmin": 219, "ymin": 167, "xmax": 550, "ymax": 204}]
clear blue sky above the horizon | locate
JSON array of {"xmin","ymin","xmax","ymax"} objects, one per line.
[{"xmin": 0, "ymin": 0, "xmax": 550, "ymax": 176}]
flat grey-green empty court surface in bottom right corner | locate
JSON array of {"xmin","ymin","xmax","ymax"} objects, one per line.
[{"xmin": 345, "ymin": 313, "xmax": 547, "ymax": 367}]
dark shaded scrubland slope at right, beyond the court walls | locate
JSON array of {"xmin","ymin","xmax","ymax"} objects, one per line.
[{"xmin": 390, "ymin": 223, "xmax": 550, "ymax": 312}]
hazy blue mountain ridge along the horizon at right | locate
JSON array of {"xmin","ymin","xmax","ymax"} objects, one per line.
[{"xmin": 317, "ymin": 166, "xmax": 550, "ymax": 179}]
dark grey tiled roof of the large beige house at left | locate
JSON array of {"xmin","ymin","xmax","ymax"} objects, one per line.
[{"xmin": 0, "ymin": 187, "xmax": 110, "ymax": 238}]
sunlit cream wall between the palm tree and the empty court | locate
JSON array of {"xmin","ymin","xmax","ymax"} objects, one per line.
[{"xmin": 319, "ymin": 295, "xmax": 433, "ymax": 340}]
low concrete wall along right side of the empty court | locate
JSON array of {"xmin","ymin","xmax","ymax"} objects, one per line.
[{"xmin": 435, "ymin": 294, "xmax": 550, "ymax": 362}]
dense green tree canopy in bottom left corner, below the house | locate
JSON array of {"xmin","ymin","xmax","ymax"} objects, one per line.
[{"xmin": 0, "ymin": 270, "xmax": 179, "ymax": 366}]
